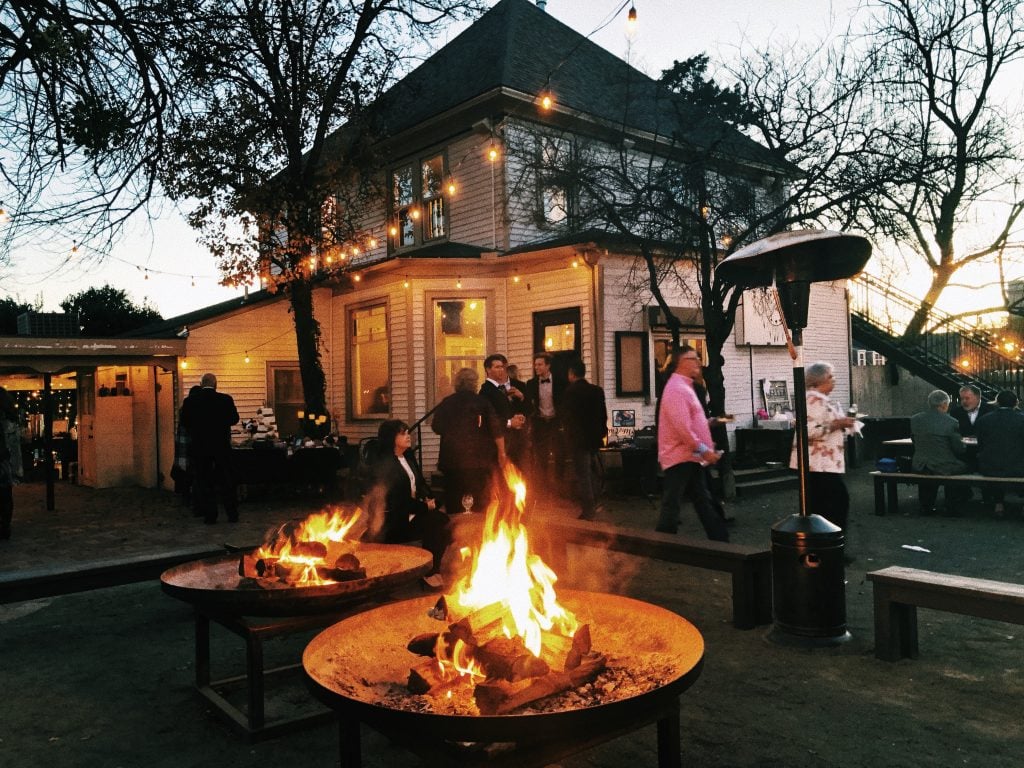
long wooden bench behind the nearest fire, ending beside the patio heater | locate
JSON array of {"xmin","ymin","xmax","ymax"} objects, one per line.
[{"xmin": 453, "ymin": 515, "xmax": 772, "ymax": 630}]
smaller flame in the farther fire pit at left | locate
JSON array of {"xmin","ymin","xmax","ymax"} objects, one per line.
[{"xmin": 254, "ymin": 507, "xmax": 362, "ymax": 586}]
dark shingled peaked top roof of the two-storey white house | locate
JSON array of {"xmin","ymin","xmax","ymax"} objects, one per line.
[{"xmin": 374, "ymin": 0, "xmax": 788, "ymax": 169}]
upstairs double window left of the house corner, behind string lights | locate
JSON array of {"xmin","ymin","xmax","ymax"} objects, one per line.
[{"xmin": 390, "ymin": 154, "xmax": 447, "ymax": 250}]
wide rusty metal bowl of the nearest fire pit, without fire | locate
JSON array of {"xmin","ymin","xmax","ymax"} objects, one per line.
[{"xmin": 302, "ymin": 590, "xmax": 703, "ymax": 753}]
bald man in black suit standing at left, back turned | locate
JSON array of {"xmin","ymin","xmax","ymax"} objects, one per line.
[{"xmin": 180, "ymin": 374, "xmax": 239, "ymax": 525}]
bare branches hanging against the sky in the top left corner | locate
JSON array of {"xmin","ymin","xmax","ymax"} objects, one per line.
[{"xmin": 0, "ymin": 0, "xmax": 174, "ymax": 262}]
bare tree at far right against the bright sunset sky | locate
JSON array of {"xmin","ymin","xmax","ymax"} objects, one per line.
[{"xmin": 849, "ymin": 0, "xmax": 1024, "ymax": 337}]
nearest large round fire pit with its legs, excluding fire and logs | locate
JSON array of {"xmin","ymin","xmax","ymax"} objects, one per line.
[{"xmin": 302, "ymin": 591, "xmax": 703, "ymax": 766}]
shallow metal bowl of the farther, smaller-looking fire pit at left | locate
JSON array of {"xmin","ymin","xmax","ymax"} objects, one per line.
[{"xmin": 160, "ymin": 544, "xmax": 433, "ymax": 616}]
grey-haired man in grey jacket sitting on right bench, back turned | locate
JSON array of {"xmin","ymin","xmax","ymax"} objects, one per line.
[{"xmin": 910, "ymin": 389, "xmax": 969, "ymax": 515}]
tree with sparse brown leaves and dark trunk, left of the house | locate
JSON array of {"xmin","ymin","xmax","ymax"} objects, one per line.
[{"xmin": 162, "ymin": 0, "xmax": 478, "ymax": 434}]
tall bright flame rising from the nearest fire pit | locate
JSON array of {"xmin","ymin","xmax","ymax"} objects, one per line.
[{"xmin": 445, "ymin": 464, "xmax": 579, "ymax": 656}]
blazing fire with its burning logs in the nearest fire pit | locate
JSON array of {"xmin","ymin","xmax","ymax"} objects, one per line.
[{"xmin": 408, "ymin": 465, "xmax": 607, "ymax": 715}]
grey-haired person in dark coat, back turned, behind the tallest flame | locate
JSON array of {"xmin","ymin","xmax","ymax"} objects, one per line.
[{"xmin": 430, "ymin": 368, "xmax": 508, "ymax": 514}]
